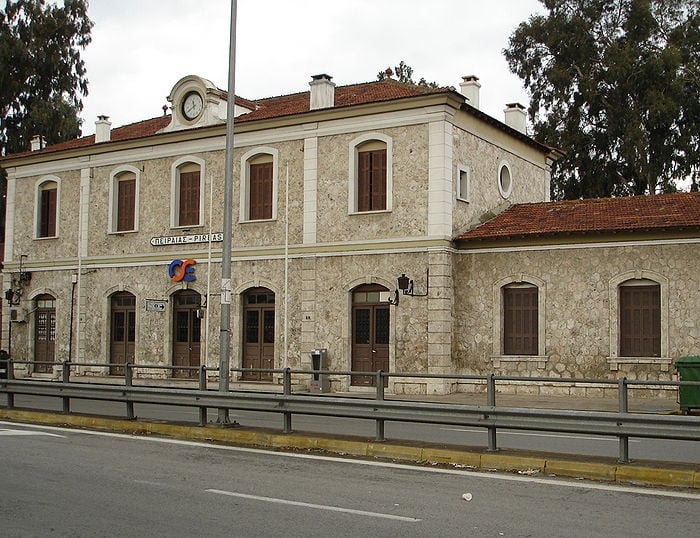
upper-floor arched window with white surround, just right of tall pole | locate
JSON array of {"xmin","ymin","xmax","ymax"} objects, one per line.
[{"xmin": 240, "ymin": 147, "xmax": 278, "ymax": 222}]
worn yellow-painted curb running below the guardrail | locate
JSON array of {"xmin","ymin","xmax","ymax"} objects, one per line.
[{"xmin": 0, "ymin": 408, "xmax": 700, "ymax": 489}]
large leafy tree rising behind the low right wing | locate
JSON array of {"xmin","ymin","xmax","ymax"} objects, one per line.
[{"xmin": 503, "ymin": 0, "xmax": 700, "ymax": 199}]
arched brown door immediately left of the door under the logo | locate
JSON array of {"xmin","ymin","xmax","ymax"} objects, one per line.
[{"xmin": 109, "ymin": 291, "xmax": 136, "ymax": 375}]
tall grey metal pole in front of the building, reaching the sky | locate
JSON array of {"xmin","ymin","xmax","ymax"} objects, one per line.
[{"xmin": 218, "ymin": 0, "xmax": 238, "ymax": 424}]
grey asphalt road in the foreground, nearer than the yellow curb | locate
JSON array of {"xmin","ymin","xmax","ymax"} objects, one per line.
[{"xmin": 0, "ymin": 422, "xmax": 700, "ymax": 538}]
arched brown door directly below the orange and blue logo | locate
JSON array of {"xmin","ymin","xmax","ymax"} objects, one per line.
[{"xmin": 173, "ymin": 290, "xmax": 202, "ymax": 377}]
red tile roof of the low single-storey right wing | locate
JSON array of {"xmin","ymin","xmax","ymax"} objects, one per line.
[{"xmin": 455, "ymin": 193, "xmax": 700, "ymax": 242}]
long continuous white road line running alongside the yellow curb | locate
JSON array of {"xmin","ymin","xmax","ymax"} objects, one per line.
[{"xmin": 0, "ymin": 421, "xmax": 700, "ymax": 501}]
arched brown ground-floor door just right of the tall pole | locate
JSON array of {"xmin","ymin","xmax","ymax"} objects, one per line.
[{"xmin": 241, "ymin": 288, "xmax": 275, "ymax": 381}]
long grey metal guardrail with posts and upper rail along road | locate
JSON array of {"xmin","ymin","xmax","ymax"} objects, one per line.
[{"xmin": 0, "ymin": 361, "xmax": 700, "ymax": 463}]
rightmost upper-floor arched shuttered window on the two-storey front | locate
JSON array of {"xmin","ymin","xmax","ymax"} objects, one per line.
[{"xmin": 348, "ymin": 133, "xmax": 392, "ymax": 213}]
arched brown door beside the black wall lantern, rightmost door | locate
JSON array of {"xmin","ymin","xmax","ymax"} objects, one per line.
[{"xmin": 351, "ymin": 284, "xmax": 389, "ymax": 387}]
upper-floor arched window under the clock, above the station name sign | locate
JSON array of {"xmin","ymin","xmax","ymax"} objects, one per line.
[{"xmin": 170, "ymin": 157, "xmax": 204, "ymax": 227}]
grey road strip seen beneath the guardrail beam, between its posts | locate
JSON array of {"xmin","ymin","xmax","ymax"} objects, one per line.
[{"xmin": 2, "ymin": 395, "xmax": 700, "ymax": 463}]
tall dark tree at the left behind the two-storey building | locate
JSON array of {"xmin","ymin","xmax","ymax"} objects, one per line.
[{"xmin": 0, "ymin": 0, "xmax": 93, "ymax": 155}]
